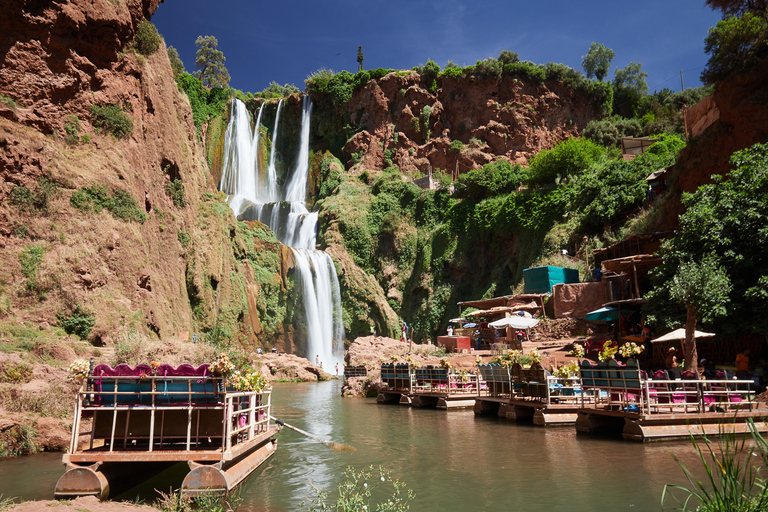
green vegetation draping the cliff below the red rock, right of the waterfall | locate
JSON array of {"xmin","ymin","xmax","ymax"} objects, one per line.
[{"xmin": 320, "ymin": 136, "xmax": 684, "ymax": 341}]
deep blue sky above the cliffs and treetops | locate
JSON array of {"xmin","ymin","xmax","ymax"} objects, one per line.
[{"xmin": 152, "ymin": 0, "xmax": 720, "ymax": 92}]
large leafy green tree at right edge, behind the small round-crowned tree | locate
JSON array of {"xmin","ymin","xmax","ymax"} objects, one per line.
[{"xmin": 646, "ymin": 144, "xmax": 768, "ymax": 335}]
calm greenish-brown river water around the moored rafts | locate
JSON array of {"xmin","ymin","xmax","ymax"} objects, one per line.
[{"xmin": 0, "ymin": 381, "xmax": 708, "ymax": 512}]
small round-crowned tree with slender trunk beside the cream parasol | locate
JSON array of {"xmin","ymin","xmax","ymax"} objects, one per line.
[{"xmin": 669, "ymin": 254, "xmax": 732, "ymax": 372}]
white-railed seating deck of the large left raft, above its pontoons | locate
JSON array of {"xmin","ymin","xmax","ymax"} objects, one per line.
[{"xmin": 70, "ymin": 375, "xmax": 271, "ymax": 454}]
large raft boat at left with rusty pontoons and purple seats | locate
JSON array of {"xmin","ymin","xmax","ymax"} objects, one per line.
[{"xmin": 54, "ymin": 364, "xmax": 279, "ymax": 499}]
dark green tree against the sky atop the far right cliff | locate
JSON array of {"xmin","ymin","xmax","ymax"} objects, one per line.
[{"xmin": 701, "ymin": 13, "xmax": 768, "ymax": 85}]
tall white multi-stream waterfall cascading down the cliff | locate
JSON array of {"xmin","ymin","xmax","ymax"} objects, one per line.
[{"xmin": 219, "ymin": 95, "xmax": 344, "ymax": 372}]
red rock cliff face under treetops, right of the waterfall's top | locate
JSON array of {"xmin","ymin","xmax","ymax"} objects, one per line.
[{"xmin": 336, "ymin": 72, "xmax": 599, "ymax": 172}]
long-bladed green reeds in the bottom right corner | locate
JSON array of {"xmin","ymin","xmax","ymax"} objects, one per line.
[{"xmin": 661, "ymin": 418, "xmax": 768, "ymax": 512}]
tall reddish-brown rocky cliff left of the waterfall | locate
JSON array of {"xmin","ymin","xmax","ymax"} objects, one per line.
[{"xmin": 0, "ymin": 0, "xmax": 292, "ymax": 350}]
